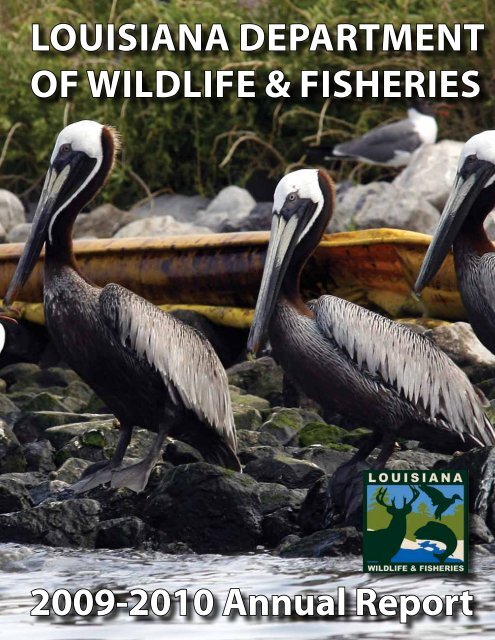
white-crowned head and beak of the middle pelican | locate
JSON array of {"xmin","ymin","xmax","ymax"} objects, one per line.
[{"xmin": 247, "ymin": 169, "xmax": 334, "ymax": 353}]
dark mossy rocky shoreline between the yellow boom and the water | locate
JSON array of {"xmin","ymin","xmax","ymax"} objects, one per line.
[{"xmin": 0, "ymin": 314, "xmax": 495, "ymax": 558}]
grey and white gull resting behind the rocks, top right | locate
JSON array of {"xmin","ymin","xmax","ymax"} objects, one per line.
[{"xmin": 311, "ymin": 99, "xmax": 438, "ymax": 167}]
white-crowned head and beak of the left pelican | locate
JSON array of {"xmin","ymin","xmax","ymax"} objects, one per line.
[{"xmin": 5, "ymin": 120, "xmax": 118, "ymax": 304}]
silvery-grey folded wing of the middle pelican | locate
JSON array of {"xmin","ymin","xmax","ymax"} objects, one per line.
[{"xmin": 310, "ymin": 295, "xmax": 495, "ymax": 445}]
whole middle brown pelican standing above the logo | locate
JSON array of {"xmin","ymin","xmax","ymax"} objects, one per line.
[{"xmin": 248, "ymin": 169, "xmax": 495, "ymax": 467}]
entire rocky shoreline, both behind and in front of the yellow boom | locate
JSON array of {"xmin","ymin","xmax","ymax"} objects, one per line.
[{"xmin": 0, "ymin": 141, "xmax": 495, "ymax": 557}]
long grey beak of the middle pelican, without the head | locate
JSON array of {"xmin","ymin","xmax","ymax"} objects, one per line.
[{"xmin": 247, "ymin": 200, "xmax": 316, "ymax": 354}]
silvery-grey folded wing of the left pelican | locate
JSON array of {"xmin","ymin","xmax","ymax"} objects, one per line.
[{"xmin": 100, "ymin": 284, "xmax": 237, "ymax": 451}]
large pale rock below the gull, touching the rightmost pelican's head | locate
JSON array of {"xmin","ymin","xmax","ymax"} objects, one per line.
[{"xmin": 394, "ymin": 140, "xmax": 464, "ymax": 211}]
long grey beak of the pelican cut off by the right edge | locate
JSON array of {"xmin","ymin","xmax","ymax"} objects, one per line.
[{"xmin": 414, "ymin": 160, "xmax": 495, "ymax": 294}]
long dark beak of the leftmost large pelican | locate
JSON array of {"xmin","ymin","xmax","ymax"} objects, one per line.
[{"xmin": 4, "ymin": 165, "xmax": 70, "ymax": 305}]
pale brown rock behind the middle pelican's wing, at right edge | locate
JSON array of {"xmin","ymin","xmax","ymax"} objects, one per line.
[{"xmin": 425, "ymin": 322, "xmax": 495, "ymax": 382}]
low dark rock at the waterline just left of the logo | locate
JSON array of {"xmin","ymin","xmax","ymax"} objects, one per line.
[{"xmin": 280, "ymin": 527, "xmax": 362, "ymax": 558}]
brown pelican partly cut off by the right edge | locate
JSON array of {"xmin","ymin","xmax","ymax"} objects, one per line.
[{"xmin": 414, "ymin": 131, "xmax": 495, "ymax": 353}]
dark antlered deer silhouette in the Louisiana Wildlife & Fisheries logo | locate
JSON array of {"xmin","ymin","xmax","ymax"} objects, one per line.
[{"xmin": 366, "ymin": 485, "xmax": 420, "ymax": 562}]
